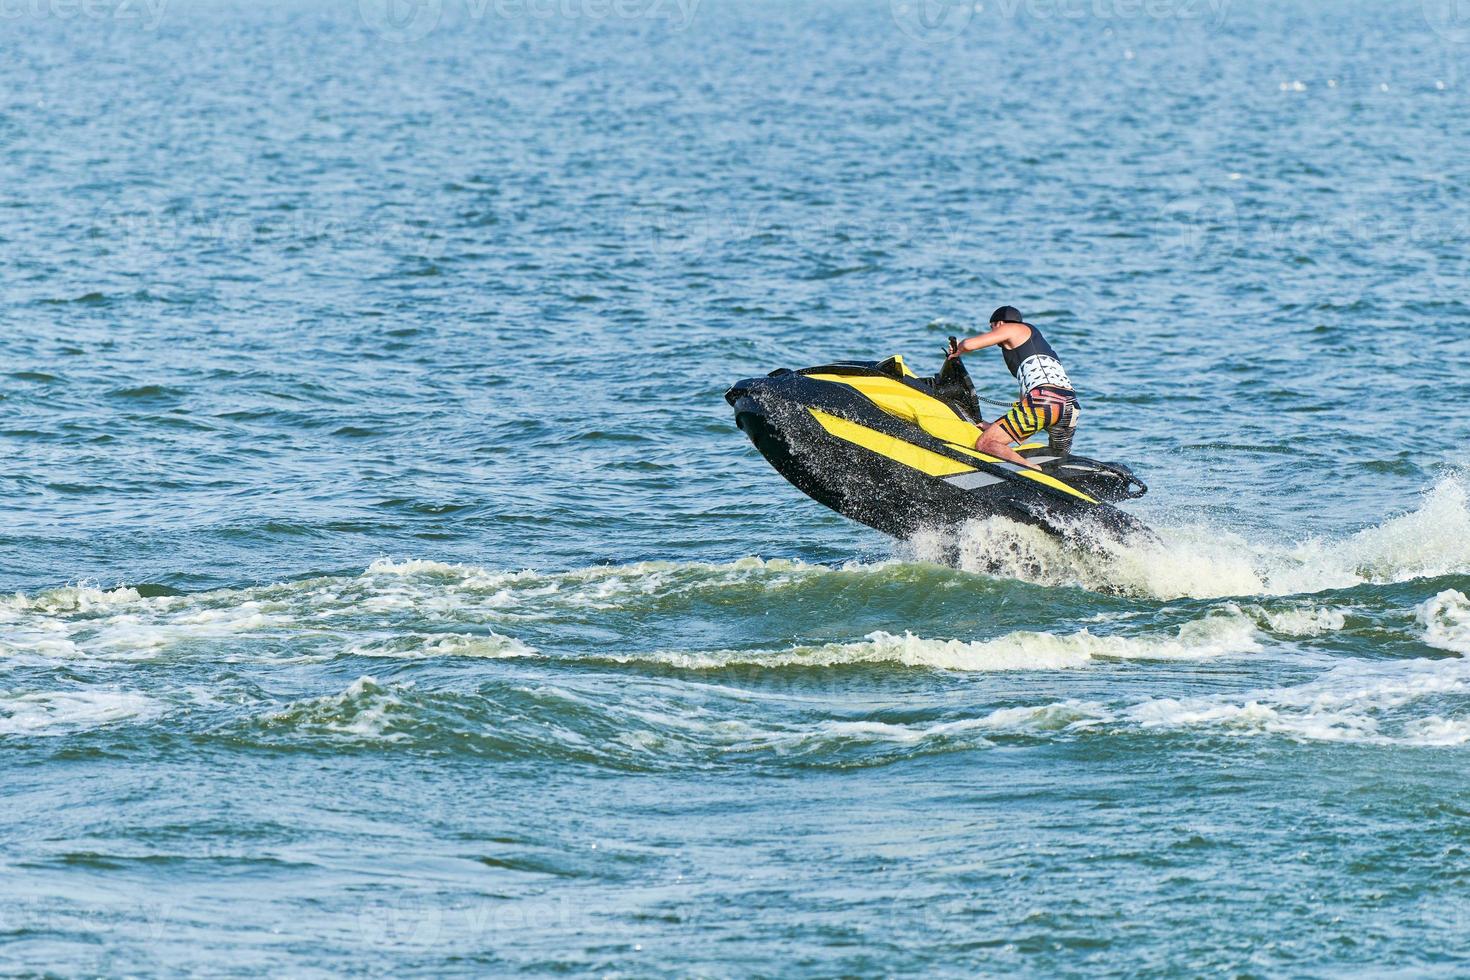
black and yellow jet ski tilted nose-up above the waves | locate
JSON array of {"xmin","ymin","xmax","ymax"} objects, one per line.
[{"xmin": 725, "ymin": 338, "xmax": 1152, "ymax": 544}]
